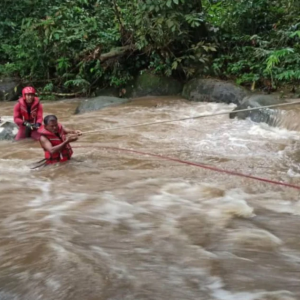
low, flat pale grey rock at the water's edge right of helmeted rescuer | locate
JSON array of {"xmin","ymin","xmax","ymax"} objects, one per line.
[{"xmin": 75, "ymin": 96, "xmax": 129, "ymax": 114}]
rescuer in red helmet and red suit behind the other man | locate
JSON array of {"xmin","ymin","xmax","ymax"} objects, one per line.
[{"xmin": 14, "ymin": 86, "xmax": 43, "ymax": 140}]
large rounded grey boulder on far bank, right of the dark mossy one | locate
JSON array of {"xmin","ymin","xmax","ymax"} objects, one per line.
[{"xmin": 182, "ymin": 78, "xmax": 249, "ymax": 104}]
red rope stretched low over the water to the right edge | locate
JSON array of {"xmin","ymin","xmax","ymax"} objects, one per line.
[{"xmin": 73, "ymin": 146, "xmax": 300, "ymax": 190}]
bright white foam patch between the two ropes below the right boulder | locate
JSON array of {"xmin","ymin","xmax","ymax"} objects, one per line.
[{"xmin": 170, "ymin": 116, "xmax": 299, "ymax": 159}]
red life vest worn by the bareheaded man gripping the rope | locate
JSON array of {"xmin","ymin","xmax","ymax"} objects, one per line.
[{"xmin": 38, "ymin": 123, "xmax": 73, "ymax": 164}]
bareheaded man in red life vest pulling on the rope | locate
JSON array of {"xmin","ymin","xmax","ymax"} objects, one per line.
[{"xmin": 38, "ymin": 115, "xmax": 82, "ymax": 164}]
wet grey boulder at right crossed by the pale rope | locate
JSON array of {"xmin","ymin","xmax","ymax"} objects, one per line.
[{"xmin": 229, "ymin": 95, "xmax": 286, "ymax": 126}]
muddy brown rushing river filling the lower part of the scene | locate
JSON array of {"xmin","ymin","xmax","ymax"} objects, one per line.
[{"xmin": 0, "ymin": 97, "xmax": 300, "ymax": 300}]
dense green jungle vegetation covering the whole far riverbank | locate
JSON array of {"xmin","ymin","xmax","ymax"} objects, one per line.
[{"xmin": 0, "ymin": 0, "xmax": 300, "ymax": 94}]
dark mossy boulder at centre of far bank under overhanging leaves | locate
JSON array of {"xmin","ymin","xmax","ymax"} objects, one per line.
[{"xmin": 124, "ymin": 73, "xmax": 183, "ymax": 98}]
